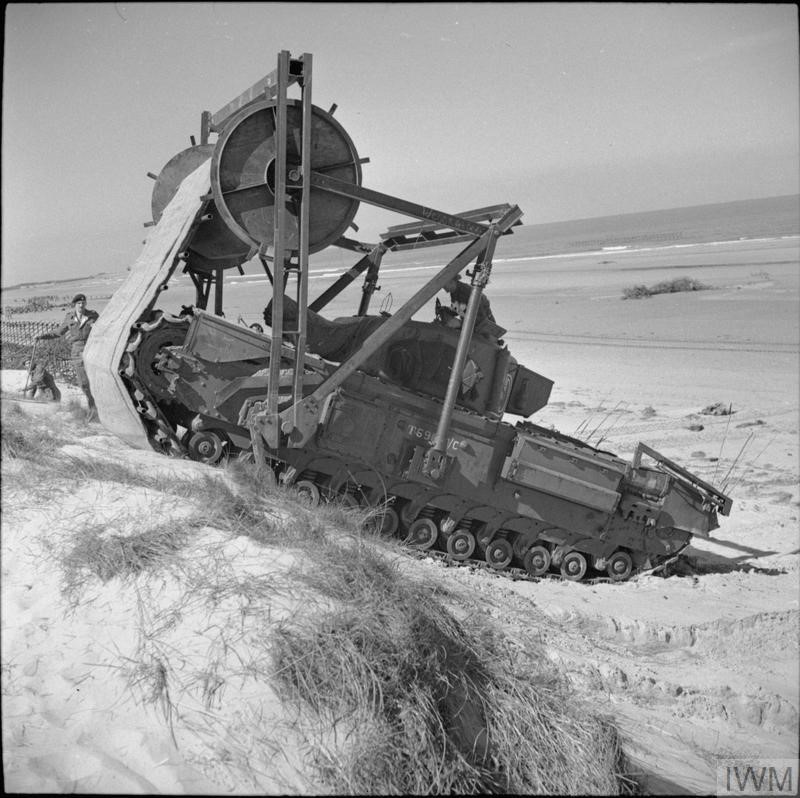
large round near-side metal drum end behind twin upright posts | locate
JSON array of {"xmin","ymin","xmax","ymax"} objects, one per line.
[{"xmin": 211, "ymin": 100, "xmax": 361, "ymax": 257}]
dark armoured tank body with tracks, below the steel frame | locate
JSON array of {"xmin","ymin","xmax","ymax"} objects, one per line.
[{"xmin": 109, "ymin": 304, "xmax": 729, "ymax": 580}]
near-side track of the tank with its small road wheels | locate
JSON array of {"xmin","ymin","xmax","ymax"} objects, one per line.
[{"xmin": 120, "ymin": 312, "xmax": 680, "ymax": 584}]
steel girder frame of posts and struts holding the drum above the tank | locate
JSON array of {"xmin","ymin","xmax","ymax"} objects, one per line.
[{"xmin": 201, "ymin": 50, "xmax": 522, "ymax": 479}]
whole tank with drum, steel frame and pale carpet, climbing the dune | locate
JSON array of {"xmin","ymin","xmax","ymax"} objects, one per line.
[{"xmin": 85, "ymin": 54, "xmax": 731, "ymax": 581}]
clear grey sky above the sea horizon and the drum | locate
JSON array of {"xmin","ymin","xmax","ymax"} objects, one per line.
[{"xmin": 2, "ymin": 3, "xmax": 800, "ymax": 286}]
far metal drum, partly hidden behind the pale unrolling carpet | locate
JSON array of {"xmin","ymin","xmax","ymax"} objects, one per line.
[{"xmin": 150, "ymin": 144, "xmax": 251, "ymax": 272}]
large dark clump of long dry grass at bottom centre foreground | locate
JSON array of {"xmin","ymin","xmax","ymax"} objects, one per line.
[{"xmin": 273, "ymin": 538, "xmax": 626, "ymax": 794}]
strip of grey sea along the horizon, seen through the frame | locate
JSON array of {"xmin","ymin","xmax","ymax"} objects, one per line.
[{"xmin": 3, "ymin": 194, "xmax": 800, "ymax": 324}]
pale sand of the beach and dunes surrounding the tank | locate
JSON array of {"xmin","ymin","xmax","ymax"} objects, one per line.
[{"xmin": 2, "ymin": 233, "xmax": 800, "ymax": 794}]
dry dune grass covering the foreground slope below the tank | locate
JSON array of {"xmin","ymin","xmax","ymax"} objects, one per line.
[{"xmin": 2, "ymin": 410, "xmax": 632, "ymax": 794}]
